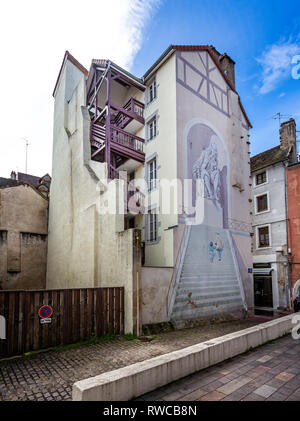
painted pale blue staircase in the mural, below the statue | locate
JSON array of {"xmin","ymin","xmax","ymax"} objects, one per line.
[{"xmin": 171, "ymin": 225, "xmax": 244, "ymax": 322}]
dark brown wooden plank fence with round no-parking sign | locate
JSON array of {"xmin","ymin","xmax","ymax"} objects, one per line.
[{"xmin": 0, "ymin": 288, "xmax": 124, "ymax": 358}]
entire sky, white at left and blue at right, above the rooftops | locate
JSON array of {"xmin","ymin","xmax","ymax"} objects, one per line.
[{"xmin": 0, "ymin": 0, "xmax": 300, "ymax": 177}]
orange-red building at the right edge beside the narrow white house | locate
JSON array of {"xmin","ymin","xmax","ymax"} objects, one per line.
[{"xmin": 287, "ymin": 162, "xmax": 300, "ymax": 299}]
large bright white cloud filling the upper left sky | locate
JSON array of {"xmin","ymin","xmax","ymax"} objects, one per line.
[{"xmin": 0, "ymin": 0, "xmax": 162, "ymax": 176}]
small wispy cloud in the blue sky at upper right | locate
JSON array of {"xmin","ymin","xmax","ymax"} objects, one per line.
[{"xmin": 257, "ymin": 41, "xmax": 300, "ymax": 95}]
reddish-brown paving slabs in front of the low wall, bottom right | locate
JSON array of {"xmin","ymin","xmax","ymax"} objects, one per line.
[{"xmin": 136, "ymin": 335, "xmax": 300, "ymax": 401}]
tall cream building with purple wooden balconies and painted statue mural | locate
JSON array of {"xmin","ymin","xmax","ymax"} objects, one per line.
[{"xmin": 47, "ymin": 45, "xmax": 253, "ymax": 333}]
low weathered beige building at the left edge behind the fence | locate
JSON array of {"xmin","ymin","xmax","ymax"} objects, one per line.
[{"xmin": 0, "ymin": 171, "xmax": 51, "ymax": 290}]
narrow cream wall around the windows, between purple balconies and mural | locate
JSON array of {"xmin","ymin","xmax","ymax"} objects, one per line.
[{"xmin": 136, "ymin": 51, "xmax": 178, "ymax": 267}]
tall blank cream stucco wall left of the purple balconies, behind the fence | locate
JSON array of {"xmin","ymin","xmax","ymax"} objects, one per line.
[{"xmin": 47, "ymin": 61, "xmax": 138, "ymax": 332}]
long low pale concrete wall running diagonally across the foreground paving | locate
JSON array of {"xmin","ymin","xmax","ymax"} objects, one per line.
[{"xmin": 73, "ymin": 314, "xmax": 294, "ymax": 401}]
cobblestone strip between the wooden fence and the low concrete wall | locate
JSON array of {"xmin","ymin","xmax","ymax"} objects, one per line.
[{"xmin": 0, "ymin": 317, "xmax": 267, "ymax": 401}]
